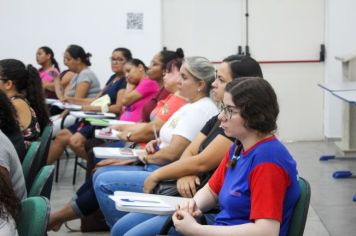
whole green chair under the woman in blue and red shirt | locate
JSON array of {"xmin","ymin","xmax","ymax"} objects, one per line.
[{"xmin": 159, "ymin": 177, "xmax": 311, "ymax": 236}]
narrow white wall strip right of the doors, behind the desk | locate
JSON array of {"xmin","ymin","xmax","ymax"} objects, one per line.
[{"xmin": 324, "ymin": 0, "xmax": 356, "ymax": 138}]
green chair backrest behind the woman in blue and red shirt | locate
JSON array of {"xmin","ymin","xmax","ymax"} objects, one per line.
[{"xmin": 287, "ymin": 177, "xmax": 311, "ymax": 236}]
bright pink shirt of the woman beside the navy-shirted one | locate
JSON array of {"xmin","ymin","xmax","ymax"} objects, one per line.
[{"xmin": 120, "ymin": 77, "xmax": 159, "ymax": 122}]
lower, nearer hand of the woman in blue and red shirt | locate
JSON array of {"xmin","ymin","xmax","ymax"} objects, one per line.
[{"xmin": 172, "ymin": 210, "xmax": 200, "ymax": 235}]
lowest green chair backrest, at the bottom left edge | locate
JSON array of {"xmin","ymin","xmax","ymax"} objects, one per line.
[{"xmin": 17, "ymin": 196, "xmax": 51, "ymax": 236}]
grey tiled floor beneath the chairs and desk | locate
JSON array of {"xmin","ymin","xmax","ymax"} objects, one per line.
[{"xmin": 48, "ymin": 141, "xmax": 356, "ymax": 236}]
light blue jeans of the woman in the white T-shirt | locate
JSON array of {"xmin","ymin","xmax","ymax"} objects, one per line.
[{"xmin": 93, "ymin": 164, "xmax": 160, "ymax": 227}]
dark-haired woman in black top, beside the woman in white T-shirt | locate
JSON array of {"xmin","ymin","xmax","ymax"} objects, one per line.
[{"xmin": 144, "ymin": 55, "xmax": 263, "ymax": 197}]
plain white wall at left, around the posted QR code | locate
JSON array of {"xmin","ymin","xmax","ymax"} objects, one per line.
[{"xmin": 0, "ymin": 0, "xmax": 161, "ymax": 84}]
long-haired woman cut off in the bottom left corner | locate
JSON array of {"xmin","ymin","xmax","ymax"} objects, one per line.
[{"xmin": 0, "ymin": 171, "xmax": 21, "ymax": 235}]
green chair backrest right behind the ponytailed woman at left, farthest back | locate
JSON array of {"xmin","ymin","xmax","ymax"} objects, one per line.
[{"xmin": 26, "ymin": 125, "xmax": 53, "ymax": 189}]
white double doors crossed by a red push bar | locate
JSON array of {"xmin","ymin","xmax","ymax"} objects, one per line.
[{"xmin": 162, "ymin": 0, "xmax": 325, "ymax": 140}]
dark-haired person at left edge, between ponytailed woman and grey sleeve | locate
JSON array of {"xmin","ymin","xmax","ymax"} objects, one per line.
[{"xmin": 0, "ymin": 90, "xmax": 26, "ymax": 162}]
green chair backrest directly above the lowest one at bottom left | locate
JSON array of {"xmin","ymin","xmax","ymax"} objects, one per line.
[{"xmin": 28, "ymin": 165, "xmax": 55, "ymax": 199}]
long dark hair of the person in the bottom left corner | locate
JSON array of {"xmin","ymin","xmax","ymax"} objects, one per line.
[{"xmin": 0, "ymin": 169, "xmax": 21, "ymax": 221}]
